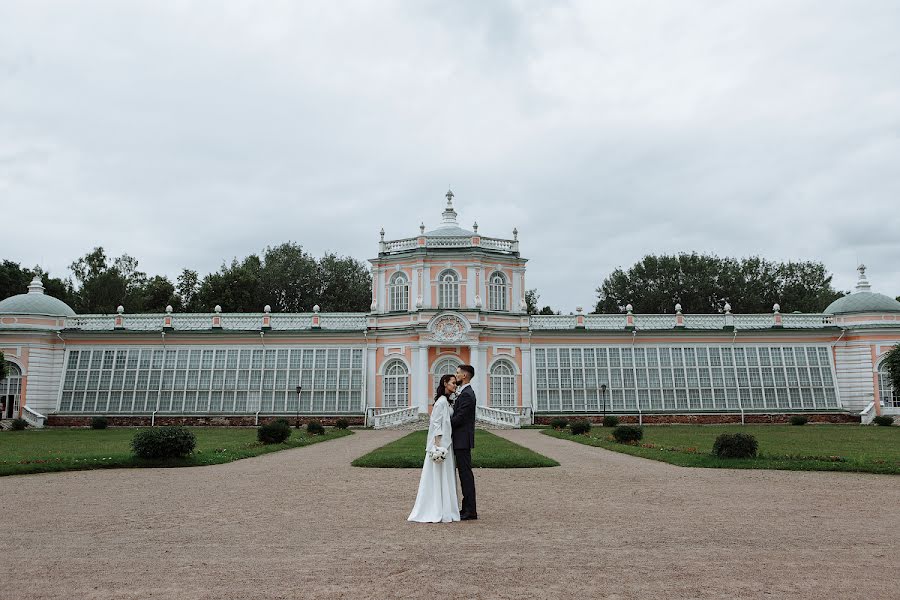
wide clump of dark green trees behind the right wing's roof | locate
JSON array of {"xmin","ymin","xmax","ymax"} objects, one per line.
[{"xmin": 595, "ymin": 252, "xmax": 842, "ymax": 313}]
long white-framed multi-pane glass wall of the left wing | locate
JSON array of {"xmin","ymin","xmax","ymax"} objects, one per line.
[{"xmin": 59, "ymin": 346, "xmax": 363, "ymax": 414}]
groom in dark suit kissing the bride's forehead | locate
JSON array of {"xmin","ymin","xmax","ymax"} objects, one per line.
[{"xmin": 450, "ymin": 365, "xmax": 478, "ymax": 521}]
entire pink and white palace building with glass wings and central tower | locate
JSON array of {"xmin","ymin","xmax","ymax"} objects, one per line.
[{"xmin": 0, "ymin": 192, "xmax": 900, "ymax": 427}]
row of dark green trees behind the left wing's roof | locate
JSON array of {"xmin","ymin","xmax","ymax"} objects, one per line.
[{"xmin": 0, "ymin": 242, "xmax": 372, "ymax": 314}]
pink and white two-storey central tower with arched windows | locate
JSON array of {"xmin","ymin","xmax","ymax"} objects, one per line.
[{"xmin": 367, "ymin": 191, "xmax": 530, "ymax": 411}]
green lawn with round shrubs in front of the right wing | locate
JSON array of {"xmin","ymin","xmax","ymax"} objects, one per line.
[{"xmin": 543, "ymin": 425, "xmax": 900, "ymax": 474}]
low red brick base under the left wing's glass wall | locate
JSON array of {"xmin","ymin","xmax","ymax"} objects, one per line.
[{"xmin": 47, "ymin": 415, "xmax": 365, "ymax": 427}]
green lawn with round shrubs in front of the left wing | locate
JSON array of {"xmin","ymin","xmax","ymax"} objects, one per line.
[{"xmin": 0, "ymin": 427, "xmax": 352, "ymax": 476}]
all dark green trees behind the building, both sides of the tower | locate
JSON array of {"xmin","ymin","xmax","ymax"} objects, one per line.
[{"xmin": 0, "ymin": 248, "xmax": 876, "ymax": 315}]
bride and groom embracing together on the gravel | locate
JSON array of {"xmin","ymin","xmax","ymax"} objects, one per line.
[{"xmin": 407, "ymin": 365, "xmax": 478, "ymax": 523}]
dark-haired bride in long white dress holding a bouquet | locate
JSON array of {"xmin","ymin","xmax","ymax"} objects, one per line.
[{"xmin": 407, "ymin": 375, "xmax": 459, "ymax": 523}]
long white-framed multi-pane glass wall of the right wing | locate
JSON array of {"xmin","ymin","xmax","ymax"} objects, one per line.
[{"xmin": 534, "ymin": 346, "xmax": 836, "ymax": 412}]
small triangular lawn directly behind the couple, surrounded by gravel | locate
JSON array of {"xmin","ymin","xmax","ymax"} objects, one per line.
[{"xmin": 353, "ymin": 429, "xmax": 559, "ymax": 469}]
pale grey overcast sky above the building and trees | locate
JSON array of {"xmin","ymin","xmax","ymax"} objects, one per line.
[{"xmin": 0, "ymin": 0, "xmax": 900, "ymax": 312}]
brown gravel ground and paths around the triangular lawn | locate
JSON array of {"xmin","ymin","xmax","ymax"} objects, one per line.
[{"xmin": 0, "ymin": 430, "xmax": 900, "ymax": 600}]
